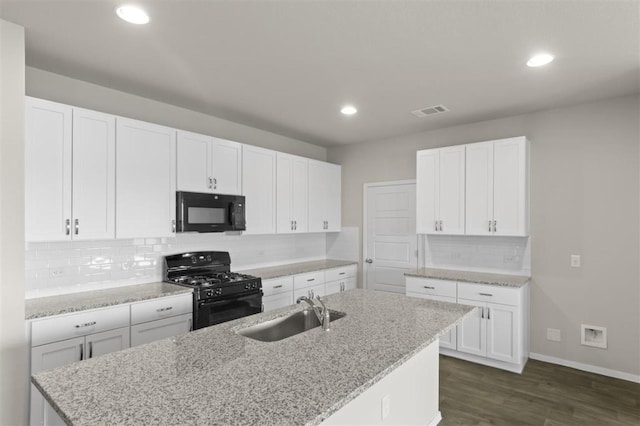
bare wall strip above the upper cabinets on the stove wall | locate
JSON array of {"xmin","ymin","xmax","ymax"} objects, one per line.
[{"xmin": 26, "ymin": 67, "xmax": 327, "ymax": 160}]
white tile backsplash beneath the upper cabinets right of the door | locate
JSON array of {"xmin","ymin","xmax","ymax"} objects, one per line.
[{"xmin": 418, "ymin": 235, "xmax": 531, "ymax": 275}]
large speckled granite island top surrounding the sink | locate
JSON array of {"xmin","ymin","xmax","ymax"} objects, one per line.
[{"xmin": 32, "ymin": 289, "xmax": 475, "ymax": 425}]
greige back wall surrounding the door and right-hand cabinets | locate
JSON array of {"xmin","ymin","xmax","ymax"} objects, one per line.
[{"xmin": 328, "ymin": 95, "xmax": 640, "ymax": 377}]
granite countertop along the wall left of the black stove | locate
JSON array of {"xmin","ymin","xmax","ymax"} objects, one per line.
[{"xmin": 25, "ymin": 282, "xmax": 192, "ymax": 320}]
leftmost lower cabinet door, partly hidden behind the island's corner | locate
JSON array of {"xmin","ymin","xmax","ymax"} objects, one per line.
[{"xmin": 30, "ymin": 337, "xmax": 84, "ymax": 425}]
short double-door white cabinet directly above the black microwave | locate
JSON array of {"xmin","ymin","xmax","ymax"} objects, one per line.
[{"xmin": 177, "ymin": 130, "xmax": 242, "ymax": 195}]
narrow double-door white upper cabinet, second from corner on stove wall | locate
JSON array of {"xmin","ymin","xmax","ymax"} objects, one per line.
[{"xmin": 276, "ymin": 153, "xmax": 309, "ymax": 234}]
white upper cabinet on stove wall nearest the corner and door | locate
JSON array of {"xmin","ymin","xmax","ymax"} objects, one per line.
[{"xmin": 308, "ymin": 160, "xmax": 342, "ymax": 232}]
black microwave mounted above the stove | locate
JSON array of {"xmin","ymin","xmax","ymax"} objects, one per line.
[{"xmin": 176, "ymin": 191, "xmax": 246, "ymax": 232}]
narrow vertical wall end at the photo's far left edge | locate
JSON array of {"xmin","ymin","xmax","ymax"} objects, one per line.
[{"xmin": 0, "ymin": 20, "xmax": 27, "ymax": 425}]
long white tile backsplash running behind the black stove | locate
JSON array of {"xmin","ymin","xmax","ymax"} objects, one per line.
[{"xmin": 25, "ymin": 233, "xmax": 327, "ymax": 299}]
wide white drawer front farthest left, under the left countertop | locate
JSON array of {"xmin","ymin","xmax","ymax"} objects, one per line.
[{"xmin": 31, "ymin": 305, "xmax": 129, "ymax": 346}]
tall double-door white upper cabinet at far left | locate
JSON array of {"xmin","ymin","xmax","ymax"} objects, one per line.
[{"xmin": 25, "ymin": 97, "xmax": 115, "ymax": 241}]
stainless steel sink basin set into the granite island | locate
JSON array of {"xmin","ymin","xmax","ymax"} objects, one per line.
[{"xmin": 238, "ymin": 309, "xmax": 347, "ymax": 342}]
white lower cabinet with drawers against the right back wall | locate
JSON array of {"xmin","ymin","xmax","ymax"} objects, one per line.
[{"xmin": 406, "ymin": 277, "xmax": 529, "ymax": 373}]
